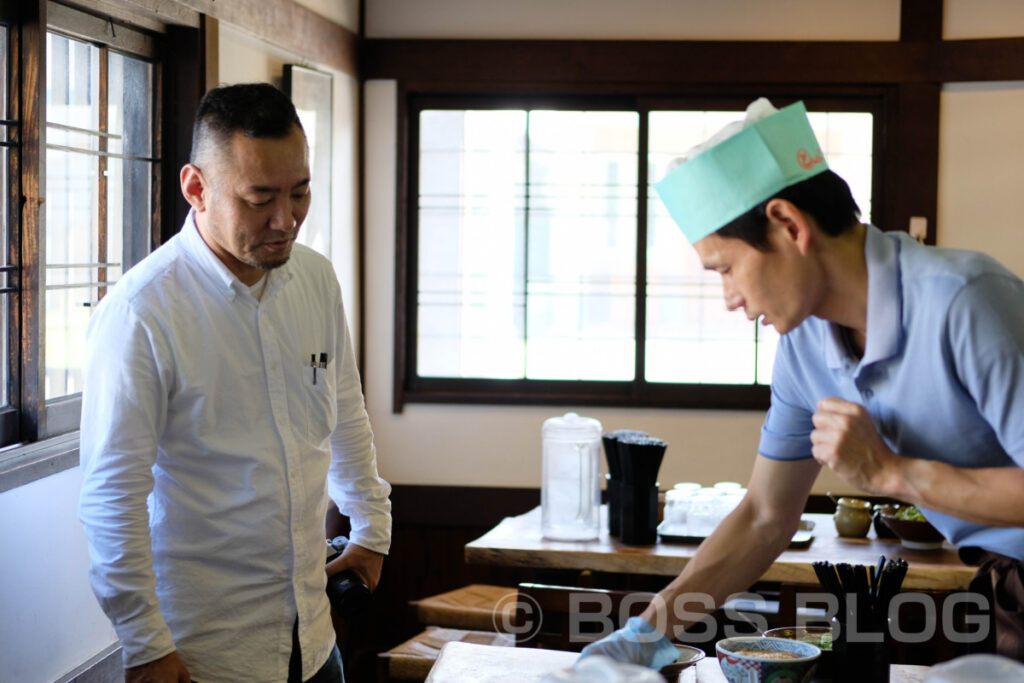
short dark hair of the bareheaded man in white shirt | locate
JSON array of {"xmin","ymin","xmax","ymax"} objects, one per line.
[{"xmin": 188, "ymin": 83, "xmax": 305, "ymax": 164}]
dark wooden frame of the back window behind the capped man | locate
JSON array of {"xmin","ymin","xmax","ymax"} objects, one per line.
[{"xmin": 395, "ymin": 86, "xmax": 892, "ymax": 410}]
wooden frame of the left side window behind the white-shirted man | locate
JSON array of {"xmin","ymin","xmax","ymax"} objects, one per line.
[{"xmin": 0, "ymin": 0, "xmax": 198, "ymax": 493}]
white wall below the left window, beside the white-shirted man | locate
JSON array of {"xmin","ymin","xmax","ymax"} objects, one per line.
[{"xmin": 0, "ymin": 467, "xmax": 117, "ymax": 683}]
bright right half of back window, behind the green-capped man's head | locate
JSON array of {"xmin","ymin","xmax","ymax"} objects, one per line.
[{"xmin": 644, "ymin": 107, "xmax": 873, "ymax": 384}]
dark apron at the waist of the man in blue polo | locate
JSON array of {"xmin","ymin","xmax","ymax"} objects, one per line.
[{"xmin": 959, "ymin": 547, "xmax": 1024, "ymax": 661}]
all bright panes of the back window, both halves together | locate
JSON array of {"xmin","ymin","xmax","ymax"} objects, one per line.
[{"xmin": 416, "ymin": 102, "xmax": 872, "ymax": 385}]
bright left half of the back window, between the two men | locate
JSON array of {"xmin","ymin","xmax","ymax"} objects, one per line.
[{"xmin": 417, "ymin": 111, "xmax": 638, "ymax": 380}]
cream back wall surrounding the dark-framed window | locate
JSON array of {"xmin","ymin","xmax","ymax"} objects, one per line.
[{"xmin": 364, "ymin": 0, "xmax": 1024, "ymax": 493}]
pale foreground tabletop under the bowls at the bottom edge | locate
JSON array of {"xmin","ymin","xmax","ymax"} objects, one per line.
[{"xmin": 427, "ymin": 642, "xmax": 928, "ymax": 683}]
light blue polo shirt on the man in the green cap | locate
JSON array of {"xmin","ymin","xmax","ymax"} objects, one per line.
[{"xmin": 758, "ymin": 226, "xmax": 1024, "ymax": 559}]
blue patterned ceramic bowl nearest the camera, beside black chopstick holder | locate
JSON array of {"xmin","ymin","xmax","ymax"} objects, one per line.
[{"xmin": 715, "ymin": 636, "xmax": 821, "ymax": 683}]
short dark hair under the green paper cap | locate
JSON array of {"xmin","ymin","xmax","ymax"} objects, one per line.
[{"xmin": 715, "ymin": 170, "xmax": 860, "ymax": 251}]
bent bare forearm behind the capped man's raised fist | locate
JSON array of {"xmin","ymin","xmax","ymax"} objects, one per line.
[{"xmin": 887, "ymin": 458, "xmax": 1024, "ymax": 526}]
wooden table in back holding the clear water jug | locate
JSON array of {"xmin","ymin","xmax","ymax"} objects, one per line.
[{"xmin": 465, "ymin": 506, "xmax": 975, "ymax": 591}]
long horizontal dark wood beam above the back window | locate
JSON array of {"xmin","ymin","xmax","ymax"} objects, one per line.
[{"xmin": 360, "ymin": 40, "xmax": 931, "ymax": 87}]
